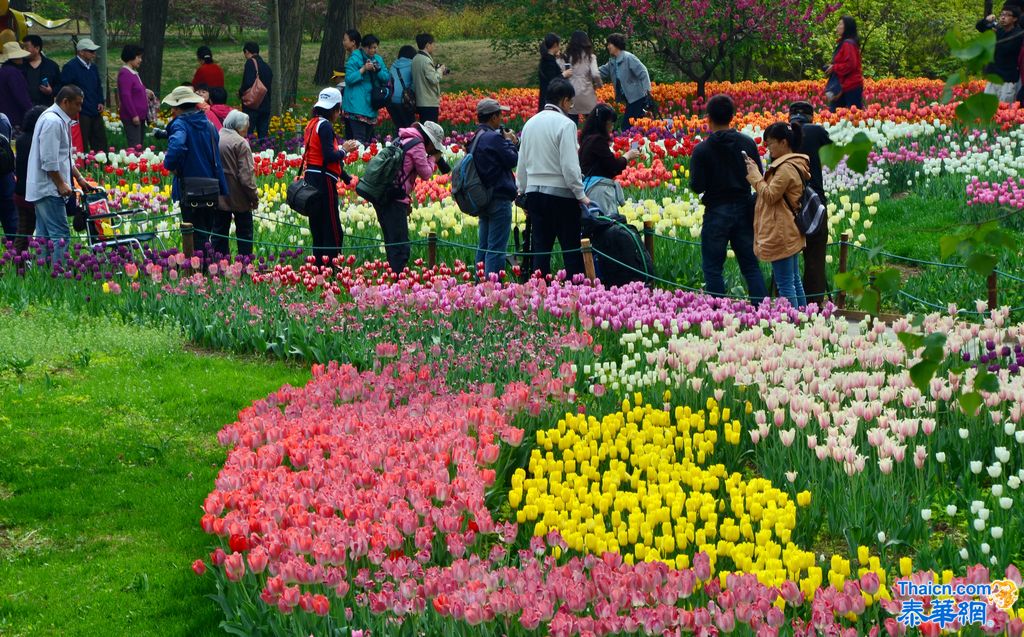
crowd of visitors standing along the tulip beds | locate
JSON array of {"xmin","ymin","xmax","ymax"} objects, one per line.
[{"xmin": 0, "ymin": 16, "xmax": 884, "ymax": 305}]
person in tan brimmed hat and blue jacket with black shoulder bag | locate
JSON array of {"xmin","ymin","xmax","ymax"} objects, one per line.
[{"xmin": 164, "ymin": 86, "xmax": 227, "ymax": 255}]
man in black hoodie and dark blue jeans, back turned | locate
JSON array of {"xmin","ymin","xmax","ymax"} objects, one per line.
[{"xmin": 690, "ymin": 95, "xmax": 768, "ymax": 303}]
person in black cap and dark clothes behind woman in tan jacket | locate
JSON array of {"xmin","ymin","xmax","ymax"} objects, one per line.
[{"xmin": 790, "ymin": 101, "xmax": 831, "ymax": 305}]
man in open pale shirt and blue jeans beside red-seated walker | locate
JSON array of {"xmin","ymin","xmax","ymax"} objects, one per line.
[{"xmin": 25, "ymin": 85, "xmax": 92, "ymax": 263}]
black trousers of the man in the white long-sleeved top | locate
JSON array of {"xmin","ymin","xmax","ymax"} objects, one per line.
[{"xmin": 526, "ymin": 193, "xmax": 583, "ymax": 278}]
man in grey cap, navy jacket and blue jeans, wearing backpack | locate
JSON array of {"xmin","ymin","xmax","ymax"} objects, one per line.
[{"xmin": 470, "ymin": 97, "xmax": 519, "ymax": 277}]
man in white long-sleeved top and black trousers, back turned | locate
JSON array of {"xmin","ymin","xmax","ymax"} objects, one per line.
[{"xmin": 516, "ymin": 78, "xmax": 590, "ymax": 278}]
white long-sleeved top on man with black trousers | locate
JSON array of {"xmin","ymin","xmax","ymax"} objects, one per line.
[{"xmin": 516, "ymin": 104, "xmax": 586, "ymax": 201}]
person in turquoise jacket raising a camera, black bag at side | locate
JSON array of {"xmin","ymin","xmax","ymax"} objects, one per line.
[{"xmin": 342, "ymin": 34, "xmax": 391, "ymax": 144}]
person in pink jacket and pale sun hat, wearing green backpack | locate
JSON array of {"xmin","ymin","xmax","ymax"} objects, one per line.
[{"xmin": 374, "ymin": 122, "xmax": 446, "ymax": 274}]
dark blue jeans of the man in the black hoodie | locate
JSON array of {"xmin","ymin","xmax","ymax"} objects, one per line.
[{"xmin": 700, "ymin": 200, "xmax": 768, "ymax": 302}]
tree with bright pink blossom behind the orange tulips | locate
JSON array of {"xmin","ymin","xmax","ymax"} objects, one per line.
[{"xmin": 591, "ymin": 0, "xmax": 840, "ymax": 97}]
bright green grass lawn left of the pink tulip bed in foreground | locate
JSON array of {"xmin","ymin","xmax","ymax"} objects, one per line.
[{"xmin": 0, "ymin": 307, "xmax": 309, "ymax": 636}]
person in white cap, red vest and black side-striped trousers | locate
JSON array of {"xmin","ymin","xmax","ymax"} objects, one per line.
[{"xmin": 303, "ymin": 88, "xmax": 359, "ymax": 265}]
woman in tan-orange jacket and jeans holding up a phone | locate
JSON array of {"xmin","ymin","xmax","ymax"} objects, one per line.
[{"xmin": 746, "ymin": 122, "xmax": 811, "ymax": 307}]
